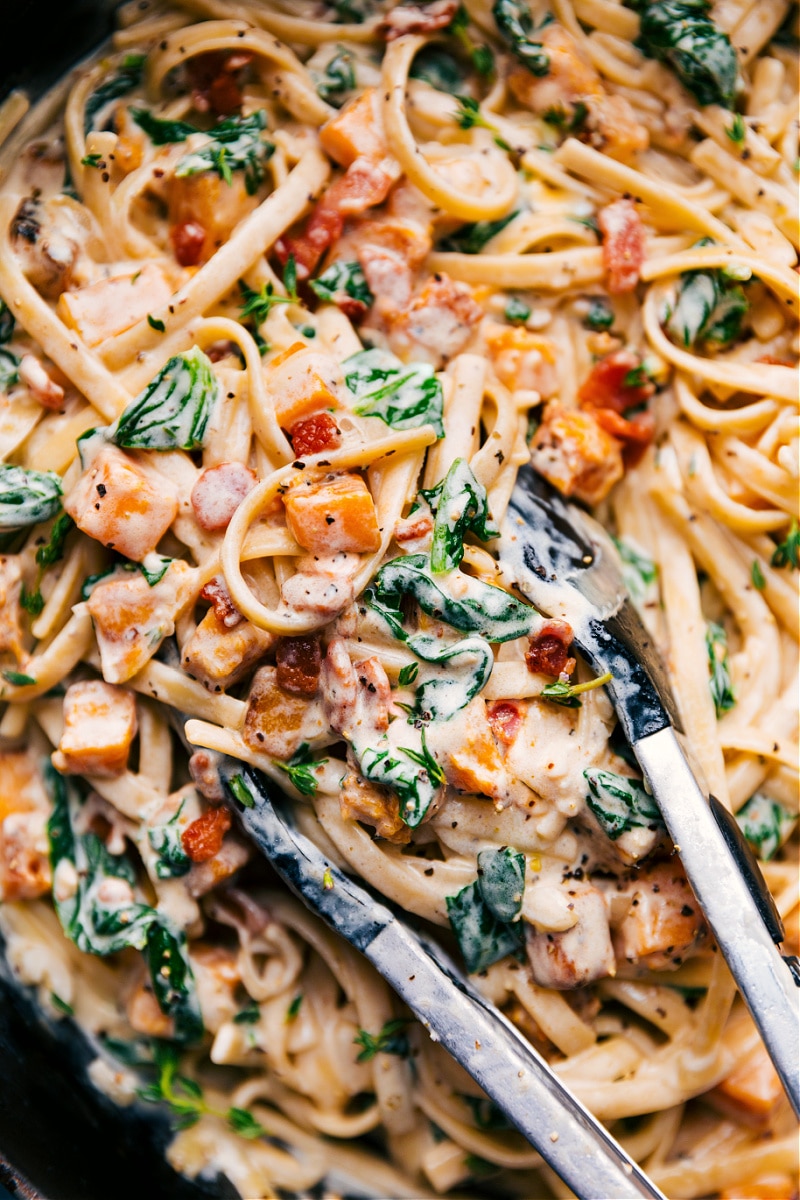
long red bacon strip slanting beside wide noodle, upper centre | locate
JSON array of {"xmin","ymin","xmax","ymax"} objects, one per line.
[{"xmin": 275, "ymin": 158, "xmax": 395, "ymax": 280}]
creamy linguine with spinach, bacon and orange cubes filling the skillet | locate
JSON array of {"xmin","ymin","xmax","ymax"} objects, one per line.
[{"xmin": 0, "ymin": 0, "xmax": 800, "ymax": 1200}]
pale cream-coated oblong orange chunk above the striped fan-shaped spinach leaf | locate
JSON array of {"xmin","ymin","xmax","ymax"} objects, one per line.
[{"xmin": 56, "ymin": 263, "xmax": 173, "ymax": 346}]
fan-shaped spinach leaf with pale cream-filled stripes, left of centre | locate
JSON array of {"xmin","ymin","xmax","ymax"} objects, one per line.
[{"xmin": 107, "ymin": 346, "xmax": 219, "ymax": 450}]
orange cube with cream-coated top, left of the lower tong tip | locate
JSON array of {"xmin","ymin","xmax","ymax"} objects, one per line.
[{"xmin": 53, "ymin": 679, "xmax": 137, "ymax": 776}]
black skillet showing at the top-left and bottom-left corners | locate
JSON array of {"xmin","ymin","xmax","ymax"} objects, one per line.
[{"xmin": 0, "ymin": 0, "xmax": 231, "ymax": 1200}]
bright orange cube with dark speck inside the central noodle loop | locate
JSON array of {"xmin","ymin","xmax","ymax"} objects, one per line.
[{"xmin": 283, "ymin": 475, "xmax": 380, "ymax": 554}]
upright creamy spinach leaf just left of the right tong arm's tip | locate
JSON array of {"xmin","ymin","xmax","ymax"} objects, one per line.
[{"xmin": 422, "ymin": 458, "xmax": 500, "ymax": 575}]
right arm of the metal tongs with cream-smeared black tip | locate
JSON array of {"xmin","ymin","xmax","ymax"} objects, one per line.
[{"xmin": 500, "ymin": 467, "xmax": 800, "ymax": 1116}]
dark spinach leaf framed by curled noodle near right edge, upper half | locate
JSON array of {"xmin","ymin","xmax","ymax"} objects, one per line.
[{"xmin": 667, "ymin": 270, "xmax": 750, "ymax": 347}]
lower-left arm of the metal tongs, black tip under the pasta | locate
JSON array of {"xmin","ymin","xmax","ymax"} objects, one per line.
[{"xmin": 219, "ymin": 758, "xmax": 666, "ymax": 1200}]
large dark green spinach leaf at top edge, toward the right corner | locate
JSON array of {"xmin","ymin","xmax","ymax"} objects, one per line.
[{"xmin": 631, "ymin": 0, "xmax": 739, "ymax": 108}]
